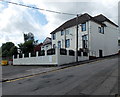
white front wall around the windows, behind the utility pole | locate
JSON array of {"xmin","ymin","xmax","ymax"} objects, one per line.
[{"xmin": 52, "ymin": 22, "xmax": 88, "ymax": 50}]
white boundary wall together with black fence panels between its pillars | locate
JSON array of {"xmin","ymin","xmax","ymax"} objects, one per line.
[{"xmin": 13, "ymin": 48, "xmax": 89, "ymax": 65}]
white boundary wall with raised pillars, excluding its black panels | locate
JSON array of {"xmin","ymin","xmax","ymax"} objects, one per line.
[{"xmin": 13, "ymin": 48, "xmax": 89, "ymax": 65}]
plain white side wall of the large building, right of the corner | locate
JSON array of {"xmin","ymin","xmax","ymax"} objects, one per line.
[{"xmin": 89, "ymin": 21, "xmax": 118, "ymax": 57}]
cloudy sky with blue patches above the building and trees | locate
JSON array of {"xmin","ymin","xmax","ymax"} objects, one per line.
[{"xmin": 0, "ymin": 0, "xmax": 119, "ymax": 46}]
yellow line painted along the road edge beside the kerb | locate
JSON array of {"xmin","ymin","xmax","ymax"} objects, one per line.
[{"xmin": 2, "ymin": 59, "xmax": 109, "ymax": 83}]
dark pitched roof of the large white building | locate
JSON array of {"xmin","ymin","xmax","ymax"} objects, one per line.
[{"xmin": 50, "ymin": 13, "xmax": 118, "ymax": 34}]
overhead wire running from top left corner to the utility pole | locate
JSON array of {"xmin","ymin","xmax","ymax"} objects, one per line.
[{"xmin": 0, "ymin": 0, "xmax": 77, "ymax": 16}]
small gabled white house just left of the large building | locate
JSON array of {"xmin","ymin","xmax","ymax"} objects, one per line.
[{"xmin": 41, "ymin": 37, "xmax": 52, "ymax": 50}]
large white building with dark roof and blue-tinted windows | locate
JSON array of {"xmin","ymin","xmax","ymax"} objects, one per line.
[{"xmin": 51, "ymin": 13, "xmax": 118, "ymax": 57}]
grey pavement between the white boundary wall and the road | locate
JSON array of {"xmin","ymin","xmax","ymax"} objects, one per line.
[{"xmin": 0, "ymin": 56, "xmax": 117, "ymax": 82}]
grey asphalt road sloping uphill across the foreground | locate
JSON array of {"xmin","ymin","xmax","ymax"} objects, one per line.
[{"xmin": 2, "ymin": 57, "xmax": 118, "ymax": 95}]
